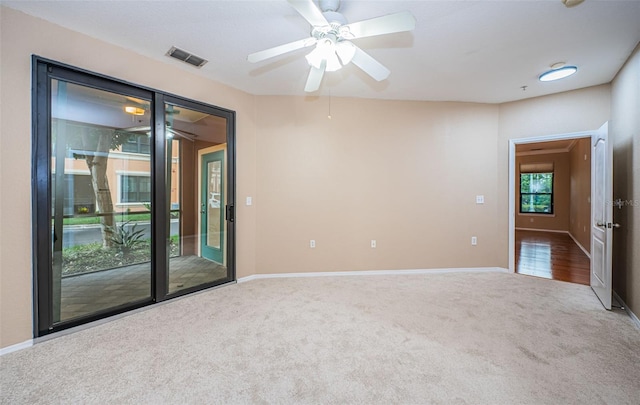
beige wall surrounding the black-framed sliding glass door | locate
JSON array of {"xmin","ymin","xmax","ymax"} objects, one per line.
[{"xmin": 0, "ymin": 7, "xmax": 256, "ymax": 347}]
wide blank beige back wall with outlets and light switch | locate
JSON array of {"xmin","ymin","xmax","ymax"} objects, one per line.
[{"xmin": 256, "ymin": 97, "xmax": 501, "ymax": 273}]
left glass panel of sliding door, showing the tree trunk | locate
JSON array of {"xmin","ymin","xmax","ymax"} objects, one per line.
[{"xmin": 50, "ymin": 79, "xmax": 152, "ymax": 323}]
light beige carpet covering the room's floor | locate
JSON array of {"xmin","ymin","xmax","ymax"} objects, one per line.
[{"xmin": 0, "ymin": 273, "xmax": 640, "ymax": 404}]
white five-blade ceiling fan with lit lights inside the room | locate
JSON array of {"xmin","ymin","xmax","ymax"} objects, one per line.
[{"xmin": 247, "ymin": 0, "xmax": 416, "ymax": 92}]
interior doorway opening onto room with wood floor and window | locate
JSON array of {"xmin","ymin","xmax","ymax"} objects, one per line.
[{"xmin": 510, "ymin": 133, "xmax": 591, "ymax": 285}]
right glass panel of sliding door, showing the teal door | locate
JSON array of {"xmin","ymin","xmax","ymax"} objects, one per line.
[{"xmin": 165, "ymin": 104, "xmax": 230, "ymax": 294}]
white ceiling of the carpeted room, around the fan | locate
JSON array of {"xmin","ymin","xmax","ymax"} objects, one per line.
[{"xmin": 1, "ymin": 0, "xmax": 640, "ymax": 103}]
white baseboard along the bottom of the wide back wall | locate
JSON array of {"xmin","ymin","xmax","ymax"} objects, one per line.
[{"xmin": 238, "ymin": 267, "xmax": 509, "ymax": 284}]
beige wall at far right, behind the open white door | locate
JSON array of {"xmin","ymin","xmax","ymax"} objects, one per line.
[{"xmin": 609, "ymin": 46, "xmax": 640, "ymax": 316}]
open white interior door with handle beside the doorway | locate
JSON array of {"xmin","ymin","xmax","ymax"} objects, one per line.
[{"xmin": 591, "ymin": 123, "xmax": 614, "ymax": 309}]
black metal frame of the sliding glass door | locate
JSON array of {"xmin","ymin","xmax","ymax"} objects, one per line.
[{"xmin": 32, "ymin": 55, "xmax": 236, "ymax": 337}]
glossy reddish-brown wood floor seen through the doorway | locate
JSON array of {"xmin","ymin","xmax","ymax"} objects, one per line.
[{"xmin": 516, "ymin": 230, "xmax": 590, "ymax": 285}]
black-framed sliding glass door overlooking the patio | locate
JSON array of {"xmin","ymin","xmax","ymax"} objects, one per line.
[{"xmin": 33, "ymin": 57, "xmax": 235, "ymax": 336}]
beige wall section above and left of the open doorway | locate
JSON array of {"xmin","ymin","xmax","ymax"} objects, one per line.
[{"xmin": 497, "ymin": 84, "xmax": 611, "ymax": 267}]
